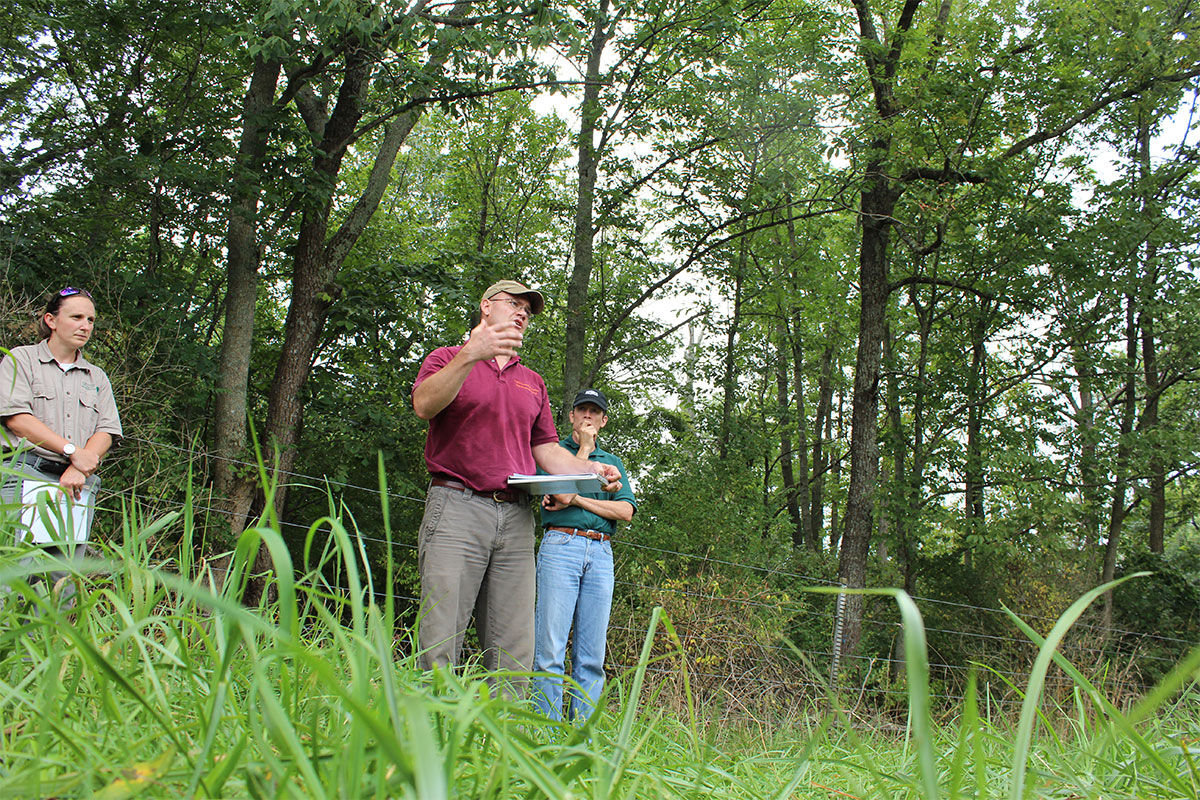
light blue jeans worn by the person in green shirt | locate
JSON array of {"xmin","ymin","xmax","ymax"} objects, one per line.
[{"xmin": 533, "ymin": 530, "xmax": 613, "ymax": 721}]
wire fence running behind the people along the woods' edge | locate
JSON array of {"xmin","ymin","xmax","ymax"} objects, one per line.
[{"xmin": 65, "ymin": 438, "xmax": 1196, "ymax": 712}]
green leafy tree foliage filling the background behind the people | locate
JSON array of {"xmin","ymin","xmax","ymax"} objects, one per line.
[{"xmin": 0, "ymin": 0, "xmax": 1200, "ymax": 714}]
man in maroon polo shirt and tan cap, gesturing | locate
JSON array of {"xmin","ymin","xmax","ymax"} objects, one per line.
[{"xmin": 413, "ymin": 281, "xmax": 620, "ymax": 691}]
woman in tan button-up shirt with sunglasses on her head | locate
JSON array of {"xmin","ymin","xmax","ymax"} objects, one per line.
[{"xmin": 0, "ymin": 287, "xmax": 121, "ymax": 585}]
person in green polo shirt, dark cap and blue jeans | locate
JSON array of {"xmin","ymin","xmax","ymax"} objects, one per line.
[{"xmin": 533, "ymin": 389, "xmax": 637, "ymax": 721}]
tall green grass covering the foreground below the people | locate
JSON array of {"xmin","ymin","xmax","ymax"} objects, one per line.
[{"xmin": 0, "ymin": 472, "xmax": 1200, "ymax": 800}]
